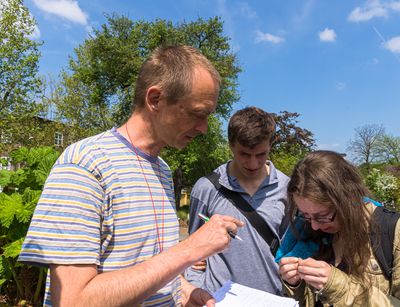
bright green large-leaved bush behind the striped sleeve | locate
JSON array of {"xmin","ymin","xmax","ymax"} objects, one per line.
[{"xmin": 0, "ymin": 147, "xmax": 59, "ymax": 304}]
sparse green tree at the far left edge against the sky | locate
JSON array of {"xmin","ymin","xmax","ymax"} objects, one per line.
[{"xmin": 0, "ymin": 0, "xmax": 43, "ymax": 153}]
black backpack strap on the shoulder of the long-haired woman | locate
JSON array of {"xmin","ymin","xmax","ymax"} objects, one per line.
[{"xmin": 371, "ymin": 206, "xmax": 400, "ymax": 280}]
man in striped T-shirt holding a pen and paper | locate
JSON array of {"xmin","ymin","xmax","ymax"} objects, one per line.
[{"xmin": 19, "ymin": 46, "xmax": 242, "ymax": 306}]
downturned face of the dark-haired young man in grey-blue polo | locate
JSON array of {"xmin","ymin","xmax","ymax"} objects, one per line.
[{"xmin": 230, "ymin": 140, "xmax": 271, "ymax": 178}]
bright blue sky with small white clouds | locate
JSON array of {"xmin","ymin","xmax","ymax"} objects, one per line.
[{"xmin": 25, "ymin": 0, "xmax": 400, "ymax": 152}]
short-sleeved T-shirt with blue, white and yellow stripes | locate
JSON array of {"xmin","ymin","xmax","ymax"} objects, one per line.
[{"xmin": 19, "ymin": 129, "xmax": 180, "ymax": 306}]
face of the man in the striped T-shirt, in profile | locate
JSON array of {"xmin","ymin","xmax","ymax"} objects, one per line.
[{"xmin": 155, "ymin": 68, "xmax": 218, "ymax": 149}]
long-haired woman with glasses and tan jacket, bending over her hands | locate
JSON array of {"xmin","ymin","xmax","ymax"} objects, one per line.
[{"xmin": 278, "ymin": 151, "xmax": 400, "ymax": 307}]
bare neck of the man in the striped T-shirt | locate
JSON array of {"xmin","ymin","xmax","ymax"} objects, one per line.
[{"xmin": 117, "ymin": 112, "xmax": 165, "ymax": 157}]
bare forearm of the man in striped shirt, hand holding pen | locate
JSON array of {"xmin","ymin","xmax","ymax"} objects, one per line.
[{"xmin": 50, "ymin": 215, "xmax": 241, "ymax": 306}]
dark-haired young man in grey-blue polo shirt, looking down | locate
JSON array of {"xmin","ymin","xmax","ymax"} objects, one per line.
[{"xmin": 185, "ymin": 107, "xmax": 289, "ymax": 294}]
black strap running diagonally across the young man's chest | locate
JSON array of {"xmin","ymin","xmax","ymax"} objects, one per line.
[{"xmin": 206, "ymin": 172, "xmax": 280, "ymax": 256}]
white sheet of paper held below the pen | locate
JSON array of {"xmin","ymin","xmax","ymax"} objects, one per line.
[{"xmin": 213, "ymin": 280, "xmax": 299, "ymax": 307}]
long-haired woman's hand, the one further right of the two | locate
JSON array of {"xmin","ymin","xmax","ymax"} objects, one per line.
[{"xmin": 296, "ymin": 258, "xmax": 331, "ymax": 290}]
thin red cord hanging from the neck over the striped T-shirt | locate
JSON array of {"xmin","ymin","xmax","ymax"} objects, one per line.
[{"xmin": 125, "ymin": 124, "xmax": 164, "ymax": 253}]
